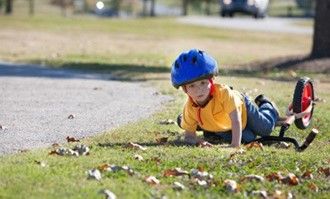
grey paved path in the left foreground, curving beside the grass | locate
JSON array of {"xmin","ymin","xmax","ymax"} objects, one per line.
[{"xmin": 0, "ymin": 63, "xmax": 170, "ymax": 156}]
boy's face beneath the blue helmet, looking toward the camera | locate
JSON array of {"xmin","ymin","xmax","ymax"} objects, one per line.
[{"xmin": 186, "ymin": 79, "xmax": 211, "ymax": 104}]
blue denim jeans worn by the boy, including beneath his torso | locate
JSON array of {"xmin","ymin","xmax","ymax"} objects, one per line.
[{"xmin": 178, "ymin": 96, "xmax": 278, "ymax": 143}]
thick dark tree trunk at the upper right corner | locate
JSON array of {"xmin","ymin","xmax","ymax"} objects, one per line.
[{"xmin": 311, "ymin": 0, "xmax": 330, "ymax": 58}]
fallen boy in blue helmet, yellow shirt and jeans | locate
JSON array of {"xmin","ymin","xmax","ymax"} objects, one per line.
[{"xmin": 171, "ymin": 49, "xmax": 279, "ymax": 147}]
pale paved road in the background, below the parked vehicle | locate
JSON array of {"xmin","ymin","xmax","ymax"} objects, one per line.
[{"xmin": 178, "ymin": 16, "xmax": 313, "ymax": 34}]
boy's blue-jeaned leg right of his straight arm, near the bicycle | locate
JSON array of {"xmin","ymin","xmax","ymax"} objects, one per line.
[{"xmin": 245, "ymin": 96, "xmax": 278, "ymax": 136}]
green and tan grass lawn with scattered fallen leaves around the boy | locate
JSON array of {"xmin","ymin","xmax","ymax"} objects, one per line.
[{"xmin": 0, "ymin": 13, "xmax": 330, "ymax": 198}]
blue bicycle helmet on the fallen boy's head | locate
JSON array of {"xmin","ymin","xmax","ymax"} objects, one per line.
[{"xmin": 171, "ymin": 49, "xmax": 218, "ymax": 88}]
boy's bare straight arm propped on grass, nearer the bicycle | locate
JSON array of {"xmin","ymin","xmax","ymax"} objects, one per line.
[{"xmin": 229, "ymin": 109, "xmax": 242, "ymax": 147}]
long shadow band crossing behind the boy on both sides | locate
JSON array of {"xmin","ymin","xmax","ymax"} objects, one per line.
[{"xmin": 0, "ymin": 56, "xmax": 330, "ymax": 82}]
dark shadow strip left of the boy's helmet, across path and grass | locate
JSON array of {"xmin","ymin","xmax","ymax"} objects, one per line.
[{"xmin": 0, "ymin": 60, "xmax": 170, "ymax": 81}]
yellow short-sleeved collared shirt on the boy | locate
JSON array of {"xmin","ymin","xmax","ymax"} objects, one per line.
[{"xmin": 181, "ymin": 84, "xmax": 247, "ymax": 132}]
